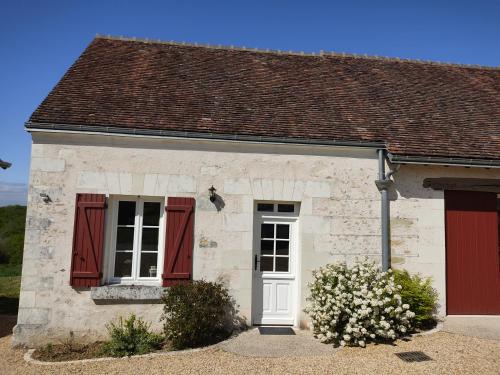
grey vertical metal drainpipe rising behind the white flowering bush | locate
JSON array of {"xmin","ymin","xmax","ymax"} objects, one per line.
[{"xmin": 375, "ymin": 149, "xmax": 399, "ymax": 272}]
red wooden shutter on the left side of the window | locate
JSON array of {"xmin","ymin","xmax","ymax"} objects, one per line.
[{"xmin": 70, "ymin": 194, "xmax": 106, "ymax": 288}]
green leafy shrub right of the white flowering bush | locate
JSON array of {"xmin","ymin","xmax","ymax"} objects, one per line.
[{"xmin": 394, "ymin": 270, "xmax": 438, "ymax": 329}]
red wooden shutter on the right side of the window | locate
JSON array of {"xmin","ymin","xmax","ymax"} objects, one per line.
[{"xmin": 162, "ymin": 197, "xmax": 195, "ymax": 286}]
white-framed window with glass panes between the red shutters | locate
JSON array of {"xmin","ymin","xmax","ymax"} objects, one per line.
[{"xmin": 108, "ymin": 197, "xmax": 165, "ymax": 284}]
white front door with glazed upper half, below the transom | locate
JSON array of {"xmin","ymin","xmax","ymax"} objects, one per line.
[{"xmin": 252, "ymin": 212, "xmax": 297, "ymax": 325}]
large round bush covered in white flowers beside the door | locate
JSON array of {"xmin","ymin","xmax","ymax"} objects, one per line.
[{"xmin": 305, "ymin": 261, "xmax": 415, "ymax": 347}]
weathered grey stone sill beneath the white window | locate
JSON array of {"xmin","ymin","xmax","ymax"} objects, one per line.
[{"xmin": 90, "ymin": 285, "xmax": 166, "ymax": 305}]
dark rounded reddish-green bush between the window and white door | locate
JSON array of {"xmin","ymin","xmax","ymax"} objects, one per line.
[{"xmin": 162, "ymin": 280, "xmax": 236, "ymax": 349}]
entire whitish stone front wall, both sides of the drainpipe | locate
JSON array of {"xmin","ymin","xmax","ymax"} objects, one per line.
[{"xmin": 14, "ymin": 131, "xmax": 500, "ymax": 345}]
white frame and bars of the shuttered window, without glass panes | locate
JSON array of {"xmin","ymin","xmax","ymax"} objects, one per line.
[{"xmin": 105, "ymin": 195, "xmax": 166, "ymax": 285}]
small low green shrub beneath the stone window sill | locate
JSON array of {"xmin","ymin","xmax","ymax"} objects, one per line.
[{"xmin": 103, "ymin": 314, "xmax": 164, "ymax": 357}]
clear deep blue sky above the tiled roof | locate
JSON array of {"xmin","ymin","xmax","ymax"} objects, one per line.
[{"xmin": 0, "ymin": 0, "xmax": 500, "ymax": 206}]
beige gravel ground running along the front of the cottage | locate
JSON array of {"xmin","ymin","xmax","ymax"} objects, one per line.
[{"xmin": 0, "ymin": 332, "xmax": 500, "ymax": 375}]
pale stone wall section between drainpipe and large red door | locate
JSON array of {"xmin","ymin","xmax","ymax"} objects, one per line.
[{"xmin": 390, "ymin": 165, "xmax": 500, "ymax": 316}]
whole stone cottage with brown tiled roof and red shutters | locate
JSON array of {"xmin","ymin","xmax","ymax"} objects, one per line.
[{"xmin": 14, "ymin": 37, "xmax": 500, "ymax": 345}]
